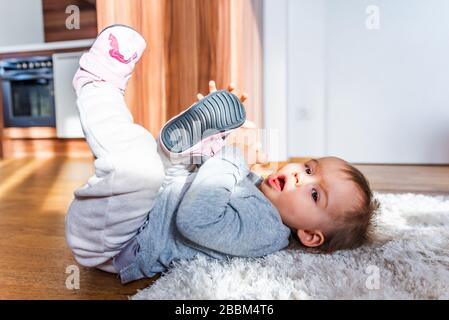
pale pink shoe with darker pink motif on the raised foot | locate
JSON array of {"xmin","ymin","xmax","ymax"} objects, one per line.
[{"xmin": 73, "ymin": 24, "xmax": 146, "ymax": 93}]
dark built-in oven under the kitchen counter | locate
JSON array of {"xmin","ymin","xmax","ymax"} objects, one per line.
[{"xmin": 0, "ymin": 56, "xmax": 56, "ymax": 127}]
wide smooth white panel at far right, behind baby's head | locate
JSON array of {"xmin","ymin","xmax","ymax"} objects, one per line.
[{"xmin": 325, "ymin": 0, "xmax": 449, "ymax": 163}]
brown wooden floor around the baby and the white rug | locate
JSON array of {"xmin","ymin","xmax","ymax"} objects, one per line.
[{"xmin": 0, "ymin": 158, "xmax": 449, "ymax": 299}]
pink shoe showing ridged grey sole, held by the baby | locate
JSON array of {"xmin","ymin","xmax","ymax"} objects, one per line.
[{"xmin": 159, "ymin": 90, "xmax": 246, "ymax": 159}]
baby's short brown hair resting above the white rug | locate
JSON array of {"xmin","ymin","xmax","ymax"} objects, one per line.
[{"xmin": 318, "ymin": 163, "xmax": 380, "ymax": 253}]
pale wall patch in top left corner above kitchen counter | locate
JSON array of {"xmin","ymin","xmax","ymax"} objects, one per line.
[{"xmin": 0, "ymin": 0, "xmax": 44, "ymax": 46}]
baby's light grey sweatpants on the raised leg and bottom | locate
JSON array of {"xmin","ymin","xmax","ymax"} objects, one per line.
[{"xmin": 65, "ymin": 82, "xmax": 171, "ymax": 272}]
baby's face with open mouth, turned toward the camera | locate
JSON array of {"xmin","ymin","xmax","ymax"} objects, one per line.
[{"xmin": 260, "ymin": 157, "xmax": 360, "ymax": 233}]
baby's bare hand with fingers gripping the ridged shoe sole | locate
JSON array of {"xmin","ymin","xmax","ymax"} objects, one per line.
[{"xmin": 197, "ymin": 80, "xmax": 267, "ymax": 166}]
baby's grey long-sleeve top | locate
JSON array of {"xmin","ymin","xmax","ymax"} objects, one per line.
[{"xmin": 114, "ymin": 147, "xmax": 290, "ymax": 283}]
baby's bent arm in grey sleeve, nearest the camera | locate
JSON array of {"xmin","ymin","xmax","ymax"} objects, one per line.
[{"xmin": 176, "ymin": 147, "xmax": 286, "ymax": 256}]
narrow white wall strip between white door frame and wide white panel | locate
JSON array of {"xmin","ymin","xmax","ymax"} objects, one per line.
[{"xmin": 287, "ymin": 0, "xmax": 326, "ymax": 157}]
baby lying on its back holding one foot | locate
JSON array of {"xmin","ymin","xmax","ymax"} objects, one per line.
[{"xmin": 66, "ymin": 25, "xmax": 377, "ymax": 283}]
